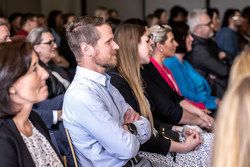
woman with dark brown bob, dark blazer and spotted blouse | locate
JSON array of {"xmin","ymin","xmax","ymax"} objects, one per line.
[{"xmin": 0, "ymin": 41, "xmax": 63, "ymax": 167}]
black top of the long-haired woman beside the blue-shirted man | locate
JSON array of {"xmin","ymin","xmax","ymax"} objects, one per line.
[{"xmin": 107, "ymin": 68, "xmax": 171, "ymax": 155}]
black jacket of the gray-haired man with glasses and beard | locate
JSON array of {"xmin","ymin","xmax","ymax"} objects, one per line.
[{"xmin": 185, "ymin": 35, "xmax": 233, "ymax": 98}]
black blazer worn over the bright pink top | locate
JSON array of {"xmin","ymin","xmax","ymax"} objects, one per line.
[{"xmin": 141, "ymin": 62, "xmax": 184, "ymax": 124}]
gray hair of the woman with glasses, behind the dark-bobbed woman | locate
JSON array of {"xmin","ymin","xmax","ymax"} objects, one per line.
[{"xmin": 27, "ymin": 27, "xmax": 50, "ymax": 47}]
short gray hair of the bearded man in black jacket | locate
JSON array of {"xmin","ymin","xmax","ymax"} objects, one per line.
[{"xmin": 187, "ymin": 9, "xmax": 207, "ymax": 33}]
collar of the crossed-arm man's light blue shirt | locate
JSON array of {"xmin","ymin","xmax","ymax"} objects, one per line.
[{"xmin": 76, "ymin": 66, "xmax": 110, "ymax": 86}]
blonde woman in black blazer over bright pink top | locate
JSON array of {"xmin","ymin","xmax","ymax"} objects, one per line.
[{"xmin": 142, "ymin": 25, "xmax": 214, "ymax": 130}]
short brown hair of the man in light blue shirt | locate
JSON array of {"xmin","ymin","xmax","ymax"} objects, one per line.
[{"xmin": 66, "ymin": 16, "xmax": 108, "ymax": 62}]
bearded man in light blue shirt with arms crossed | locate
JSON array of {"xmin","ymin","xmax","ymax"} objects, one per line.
[{"xmin": 62, "ymin": 16, "xmax": 151, "ymax": 167}]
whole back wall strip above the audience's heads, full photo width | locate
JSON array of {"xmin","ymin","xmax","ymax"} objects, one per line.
[{"xmin": 0, "ymin": 0, "xmax": 250, "ymax": 20}]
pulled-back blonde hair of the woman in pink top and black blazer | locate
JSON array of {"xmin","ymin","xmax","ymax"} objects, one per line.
[{"xmin": 149, "ymin": 25, "xmax": 172, "ymax": 44}]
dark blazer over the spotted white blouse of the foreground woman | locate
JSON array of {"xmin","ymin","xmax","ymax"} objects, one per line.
[{"xmin": 0, "ymin": 111, "xmax": 63, "ymax": 167}]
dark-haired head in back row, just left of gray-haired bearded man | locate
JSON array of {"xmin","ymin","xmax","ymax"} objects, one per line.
[{"xmin": 169, "ymin": 5, "xmax": 188, "ymax": 24}]
